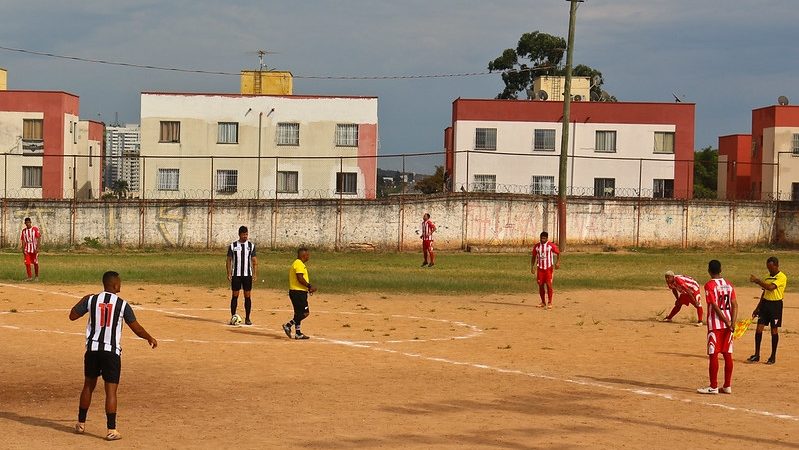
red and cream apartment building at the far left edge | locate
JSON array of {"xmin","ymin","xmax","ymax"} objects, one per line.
[{"xmin": 0, "ymin": 91, "xmax": 103, "ymax": 199}]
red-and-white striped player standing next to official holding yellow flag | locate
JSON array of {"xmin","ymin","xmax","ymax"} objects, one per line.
[{"xmin": 696, "ymin": 259, "xmax": 738, "ymax": 394}]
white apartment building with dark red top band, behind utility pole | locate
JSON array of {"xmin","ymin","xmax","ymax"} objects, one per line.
[{"xmin": 444, "ymin": 99, "xmax": 695, "ymax": 198}]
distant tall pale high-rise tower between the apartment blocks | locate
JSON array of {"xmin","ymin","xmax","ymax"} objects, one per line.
[{"xmin": 105, "ymin": 124, "xmax": 141, "ymax": 193}]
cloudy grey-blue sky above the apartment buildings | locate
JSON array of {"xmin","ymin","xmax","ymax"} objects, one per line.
[{"xmin": 0, "ymin": 0, "xmax": 799, "ymax": 173}]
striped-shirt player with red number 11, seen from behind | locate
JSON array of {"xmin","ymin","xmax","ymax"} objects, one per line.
[{"xmin": 69, "ymin": 272, "xmax": 158, "ymax": 441}]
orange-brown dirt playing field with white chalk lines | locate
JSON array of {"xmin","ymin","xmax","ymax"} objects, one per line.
[{"xmin": 0, "ymin": 284, "xmax": 799, "ymax": 449}]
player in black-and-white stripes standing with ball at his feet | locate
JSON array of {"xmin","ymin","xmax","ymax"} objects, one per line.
[{"xmin": 227, "ymin": 225, "xmax": 258, "ymax": 325}]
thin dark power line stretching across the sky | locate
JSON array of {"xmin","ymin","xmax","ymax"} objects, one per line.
[{"xmin": 0, "ymin": 46, "xmax": 553, "ymax": 80}]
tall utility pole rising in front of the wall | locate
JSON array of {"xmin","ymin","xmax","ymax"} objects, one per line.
[{"xmin": 558, "ymin": 0, "xmax": 583, "ymax": 250}]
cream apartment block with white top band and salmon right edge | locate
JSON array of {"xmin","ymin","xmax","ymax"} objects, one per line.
[{"xmin": 141, "ymin": 92, "xmax": 378, "ymax": 199}]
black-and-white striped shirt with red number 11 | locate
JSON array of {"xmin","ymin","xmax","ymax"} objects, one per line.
[{"xmin": 77, "ymin": 292, "xmax": 136, "ymax": 355}]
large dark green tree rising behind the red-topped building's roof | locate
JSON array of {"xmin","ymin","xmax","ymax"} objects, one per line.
[{"xmin": 488, "ymin": 31, "xmax": 616, "ymax": 101}]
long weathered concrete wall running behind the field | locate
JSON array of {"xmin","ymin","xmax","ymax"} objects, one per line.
[{"xmin": 0, "ymin": 194, "xmax": 799, "ymax": 251}]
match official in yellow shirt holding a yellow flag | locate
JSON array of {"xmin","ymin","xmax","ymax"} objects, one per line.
[{"xmin": 747, "ymin": 256, "xmax": 788, "ymax": 364}]
